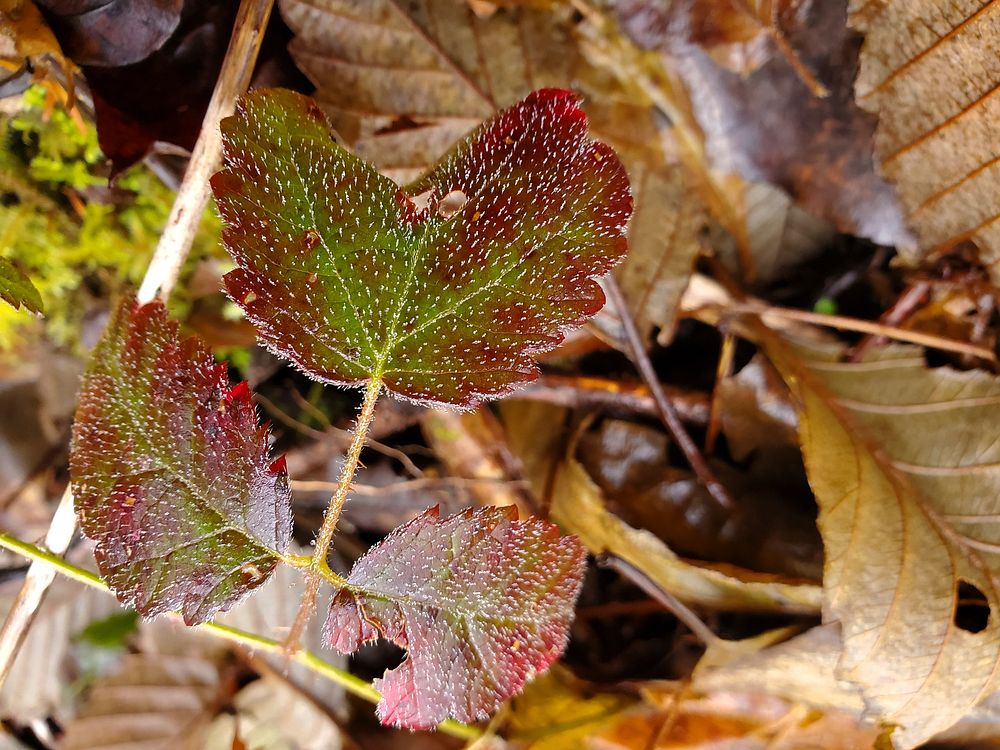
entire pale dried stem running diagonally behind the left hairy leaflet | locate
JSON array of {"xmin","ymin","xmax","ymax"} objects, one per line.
[{"xmin": 0, "ymin": 0, "xmax": 274, "ymax": 685}]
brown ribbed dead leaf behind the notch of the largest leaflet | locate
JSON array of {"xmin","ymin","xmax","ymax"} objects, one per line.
[{"xmin": 281, "ymin": 0, "xmax": 574, "ymax": 184}]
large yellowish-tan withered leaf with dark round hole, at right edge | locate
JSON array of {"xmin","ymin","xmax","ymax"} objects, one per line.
[{"xmin": 767, "ymin": 337, "xmax": 1000, "ymax": 748}]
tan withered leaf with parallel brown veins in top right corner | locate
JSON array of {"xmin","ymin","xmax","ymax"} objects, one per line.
[{"xmin": 850, "ymin": 0, "xmax": 1000, "ymax": 279}]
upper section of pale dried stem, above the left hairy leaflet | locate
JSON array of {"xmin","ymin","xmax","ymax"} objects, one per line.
[{"xmin": 137, "ymin": 0, "xmax": 274, "ymax": 302}]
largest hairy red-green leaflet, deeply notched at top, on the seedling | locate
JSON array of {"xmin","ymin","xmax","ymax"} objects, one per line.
[{"xmin": 212, "ymin": 89, "xmax": 632, "ymax": 406}]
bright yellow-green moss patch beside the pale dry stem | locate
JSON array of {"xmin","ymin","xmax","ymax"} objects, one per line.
[{"xmin": 0, "ymin": 88, "xmax": 226, "ymax": 353}]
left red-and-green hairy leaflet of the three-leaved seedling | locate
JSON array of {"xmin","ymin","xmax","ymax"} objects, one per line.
[{"xmin": 70, "ymin": 300, "xmax": 291, "ymax": 624}]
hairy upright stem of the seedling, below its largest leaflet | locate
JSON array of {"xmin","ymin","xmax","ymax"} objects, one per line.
[{"xmin": 285, "ymin": 375, "xmax": 382, "ymax": 653}]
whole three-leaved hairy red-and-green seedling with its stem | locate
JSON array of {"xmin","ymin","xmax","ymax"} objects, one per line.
[{"xmin": 71, "ymin": 89, "xmax": 632, "ymax": 729}]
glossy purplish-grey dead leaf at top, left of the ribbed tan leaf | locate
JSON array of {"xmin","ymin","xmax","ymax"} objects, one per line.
[{"xmin": 617, "ymin": 0, "xmax": 911, "ymax": 250}]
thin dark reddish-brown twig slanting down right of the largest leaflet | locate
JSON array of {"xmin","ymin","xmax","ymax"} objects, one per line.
[{"xmin": 604, "ymin": 274, "xmax": 735, "ymax": 510}]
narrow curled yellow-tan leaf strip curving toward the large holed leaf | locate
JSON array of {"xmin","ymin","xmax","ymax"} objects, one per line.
[{"xmin": 501, "ymin": 401, "xmax": 821, "ymax": 612}]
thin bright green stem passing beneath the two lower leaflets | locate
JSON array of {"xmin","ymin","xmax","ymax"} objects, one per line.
[{"xmin": 0, "ymin": 531, "xmax": 481, "ymax": 740}]
